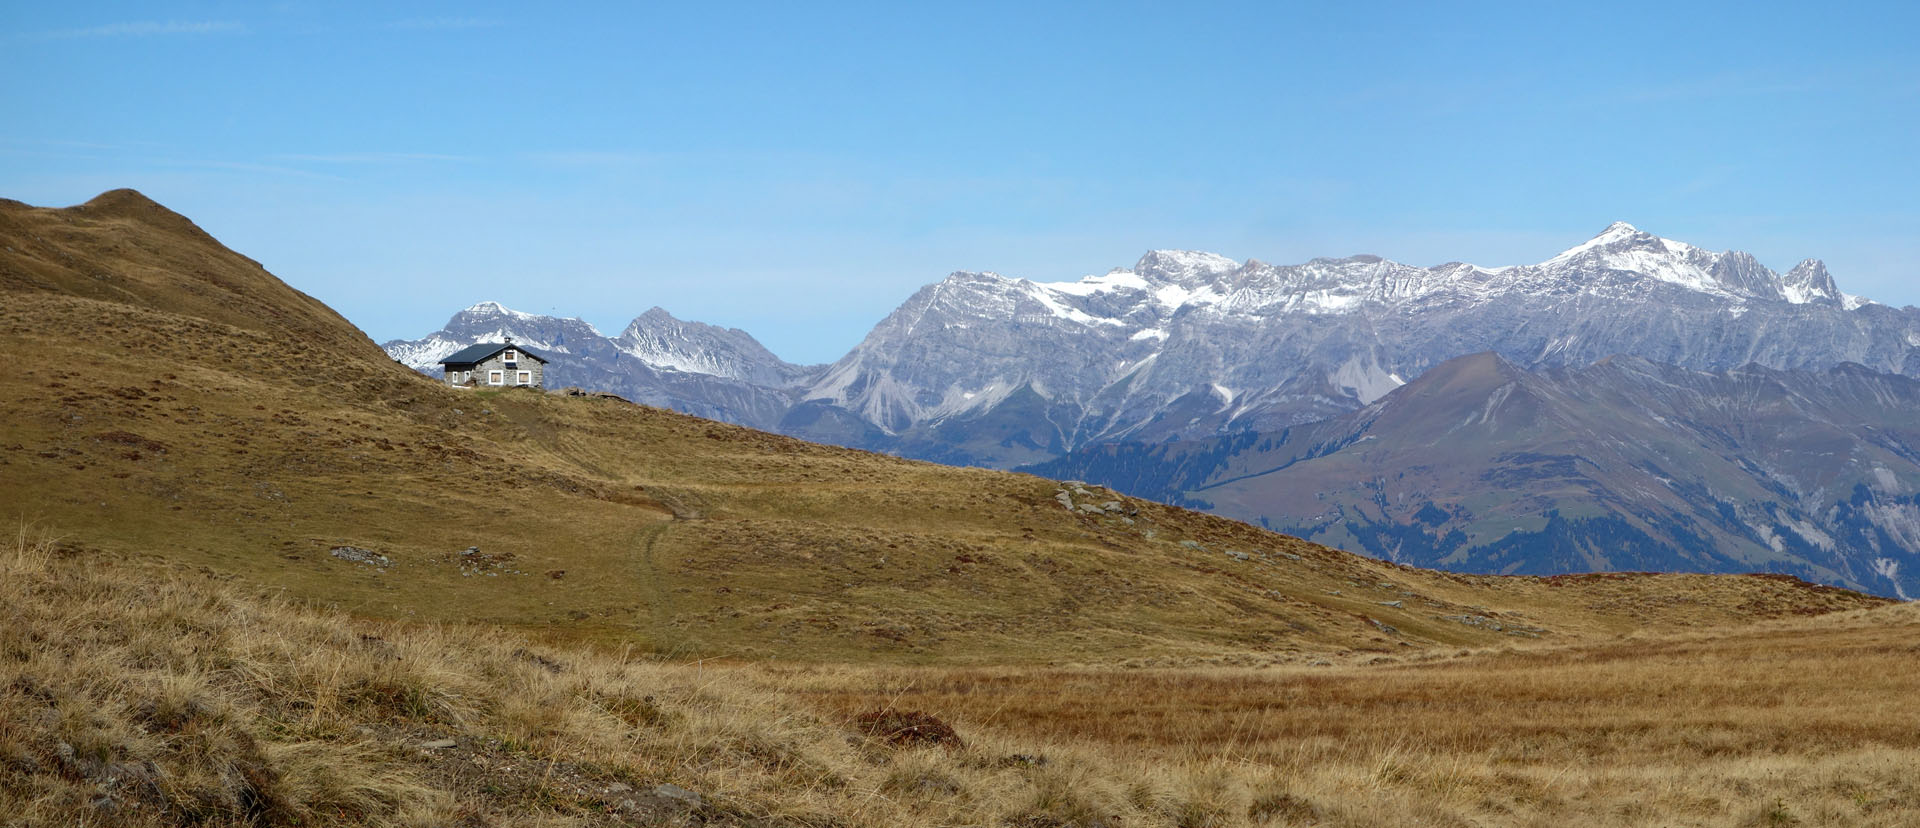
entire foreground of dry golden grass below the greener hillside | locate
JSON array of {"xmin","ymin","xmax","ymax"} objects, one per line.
[{"xmin": 0, "ymin": 534, "xmax": 1920, "ymax": 826}]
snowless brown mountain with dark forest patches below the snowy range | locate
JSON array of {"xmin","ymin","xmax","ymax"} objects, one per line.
[{"xmin": 1033, "ymin": 353, "xmax": 1920, "ymax": 597}]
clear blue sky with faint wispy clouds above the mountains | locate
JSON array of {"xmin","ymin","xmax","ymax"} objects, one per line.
[{"xmin": 0, "ymin": 2, "xmax": 1920, "ymax": 361}]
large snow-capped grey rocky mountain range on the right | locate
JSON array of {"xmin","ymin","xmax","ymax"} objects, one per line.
[{"xmin": 803, "ymin": 223, "xmax": 1920, "ymax": 465}]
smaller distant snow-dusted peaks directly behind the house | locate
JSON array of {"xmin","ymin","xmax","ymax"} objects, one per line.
[{"xmin": 382, "ymin": 302, "xmax": 818, "ymax": 430}]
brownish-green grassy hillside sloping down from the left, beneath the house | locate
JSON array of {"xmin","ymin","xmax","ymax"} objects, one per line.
[{"xmin": 0, "ymin": 190, "xmax": 1876, "ymax": 663}]
